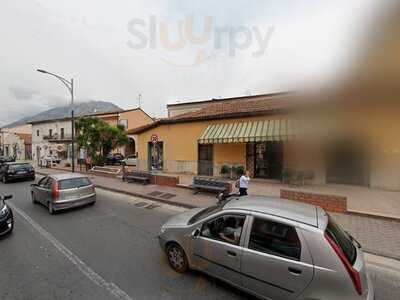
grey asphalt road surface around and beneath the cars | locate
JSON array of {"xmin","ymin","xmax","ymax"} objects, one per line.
[{"xmin": 0, "ymin": 182, "xmax": 400, "ymax": 300}]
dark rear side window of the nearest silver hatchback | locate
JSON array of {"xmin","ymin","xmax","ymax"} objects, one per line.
[{"xmin": 249, "ymin": 218, "xmax": 301, "ymax": 260}]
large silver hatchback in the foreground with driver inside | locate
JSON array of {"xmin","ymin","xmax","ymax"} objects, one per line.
[{"xmin": 159, "ymin": 197, "xmax": 374, "ymax": 300}]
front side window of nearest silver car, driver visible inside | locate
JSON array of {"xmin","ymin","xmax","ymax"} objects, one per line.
[{"xmin": 201, "ymin": 215, "xmax": 246, "ymax": 245}]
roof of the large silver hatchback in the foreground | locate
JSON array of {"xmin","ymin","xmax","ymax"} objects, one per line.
[{"xmin": 224, "ymin": 196, "xmax": 319, "ymax": 227}]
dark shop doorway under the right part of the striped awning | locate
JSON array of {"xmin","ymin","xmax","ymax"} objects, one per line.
[{"xmin": 254, "ymin": 142, "xmax": 283, "ymax": 180}]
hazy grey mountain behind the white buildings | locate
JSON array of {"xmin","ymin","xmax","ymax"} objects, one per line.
[{"xmin": 2, "ymin": 101, "xmax": 122, "ymax": 128}]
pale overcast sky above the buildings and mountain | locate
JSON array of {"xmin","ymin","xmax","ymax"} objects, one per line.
[{"xmin": 0, "ymin": 0, "xmax": 377, "ymax": 126}]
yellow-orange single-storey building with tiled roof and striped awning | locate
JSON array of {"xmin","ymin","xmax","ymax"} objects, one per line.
[{"xmin": 131, "ymin": 95, "xmax": 400, "ymax": 190}]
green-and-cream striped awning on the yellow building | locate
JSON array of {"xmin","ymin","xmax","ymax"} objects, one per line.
[{"xmin": 199, "ymin": 119, "xmax": 295, "ymax": 144}]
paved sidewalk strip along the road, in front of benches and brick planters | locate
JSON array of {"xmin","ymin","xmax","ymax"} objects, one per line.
[{"xmin": 37, "ymin": 169, "xmax": 400, "ymax": 260}]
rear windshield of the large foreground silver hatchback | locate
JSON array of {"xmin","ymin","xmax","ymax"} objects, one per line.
[{"xmin": 326, "ymin": 216, "xmax": 357, "ymax": 265}]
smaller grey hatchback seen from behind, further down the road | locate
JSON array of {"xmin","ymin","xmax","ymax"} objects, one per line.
[{"xmin": 31, "ymin": 173, "xmax": 96, "ymax": 214}]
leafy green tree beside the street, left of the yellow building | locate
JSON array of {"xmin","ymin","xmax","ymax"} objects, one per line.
[{"xmin": 75, "ymin": 117, "xmax": 129, "ymax": 162}]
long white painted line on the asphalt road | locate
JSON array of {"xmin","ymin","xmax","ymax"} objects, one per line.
[{"xmin": 8, "ymin": 203, "xmax": 133, "ymax": 300}]
